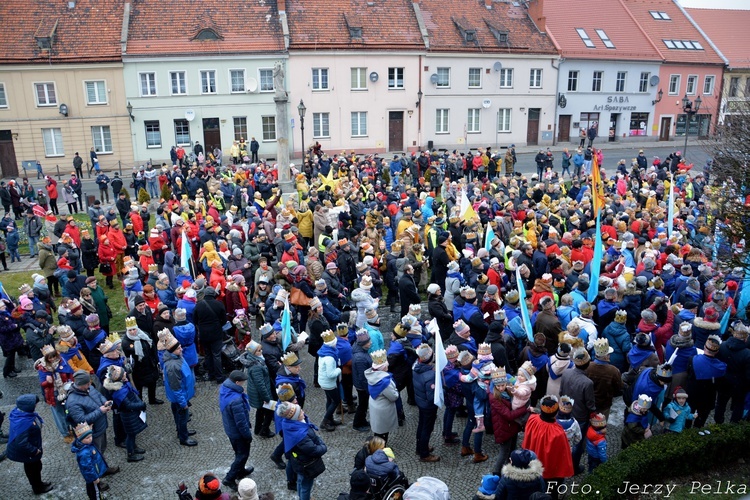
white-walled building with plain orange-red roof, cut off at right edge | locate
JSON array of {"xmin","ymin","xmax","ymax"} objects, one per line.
[{"xmin": 686, "ymin": 9, "xmax": 750, "ymax": 124}]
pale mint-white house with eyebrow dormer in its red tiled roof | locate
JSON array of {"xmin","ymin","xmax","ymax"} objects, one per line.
[{"xmin": 123, "ymin": 0, "xmax": 291, "ymax": 163}]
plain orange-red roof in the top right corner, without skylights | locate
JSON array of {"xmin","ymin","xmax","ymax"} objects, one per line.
[{"xmin": 685, "ymin": 9, "xmax": 750, "ymax": 69}]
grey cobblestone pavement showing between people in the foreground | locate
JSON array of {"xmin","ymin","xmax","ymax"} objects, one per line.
[{"xmin": 0, "ymin": 307, "xmax": 623, "ymax": 500}]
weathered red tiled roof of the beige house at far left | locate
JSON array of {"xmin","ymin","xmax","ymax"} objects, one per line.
[{"xmin": 0, "ymin": 0, "xmax": 124, "ymax": 64}]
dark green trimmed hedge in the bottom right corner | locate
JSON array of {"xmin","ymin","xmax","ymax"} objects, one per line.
[{"xmin": 583, "ymin": 422, "xmax": 750, "ymax": 499}]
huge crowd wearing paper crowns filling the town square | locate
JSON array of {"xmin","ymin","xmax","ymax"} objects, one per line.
[{"xmin": 0, "ymin": 140, "xmax": 750, "ymax": 500}]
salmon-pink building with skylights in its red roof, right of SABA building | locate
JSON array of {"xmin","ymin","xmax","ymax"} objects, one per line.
[{"xmin": 622, "ymin": 0, "xmax": 725, "ymax": 140}]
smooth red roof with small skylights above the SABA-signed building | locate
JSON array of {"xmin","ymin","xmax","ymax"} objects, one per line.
[{"xmin": 544, "ymin": 0, "xmax": 662, "ymax": 61}]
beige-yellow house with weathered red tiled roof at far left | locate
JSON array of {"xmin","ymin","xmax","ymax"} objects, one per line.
[{"xmin": 0, "ymin": 0, "xmax": 133, "ymax": 177}]
